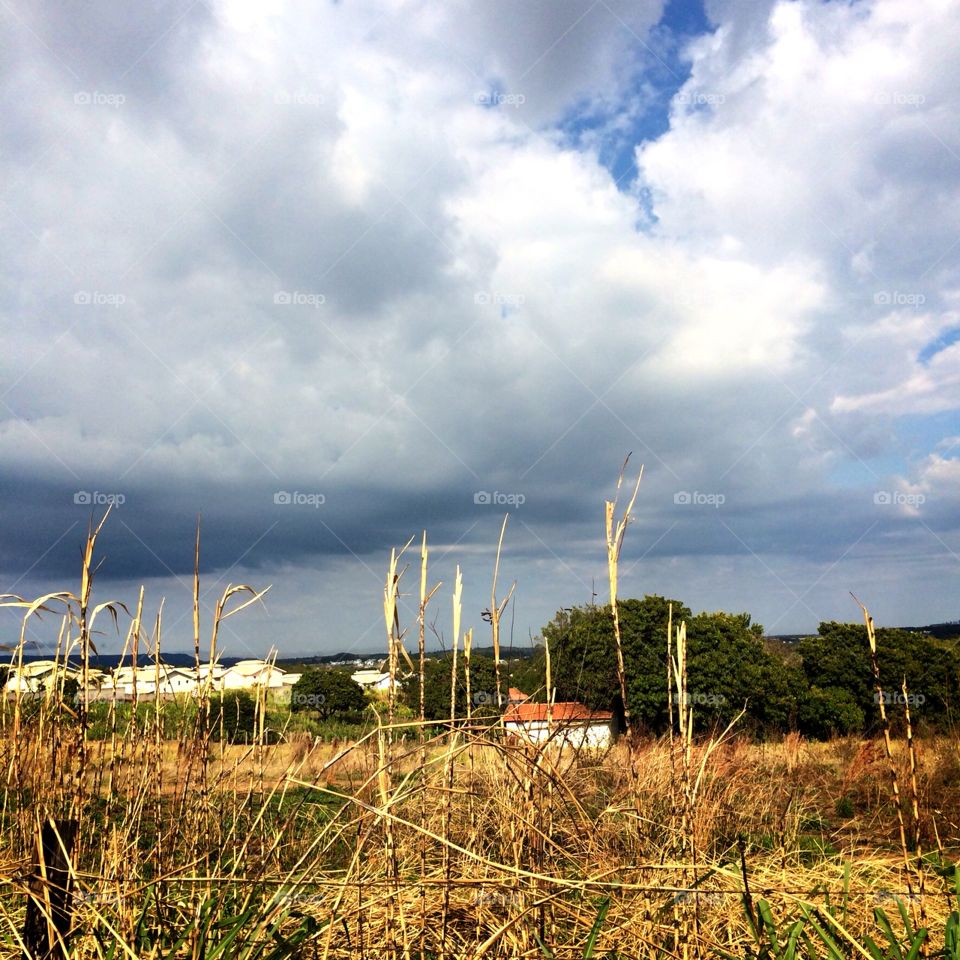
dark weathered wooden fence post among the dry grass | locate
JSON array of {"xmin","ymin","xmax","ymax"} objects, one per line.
[{"xmin": 23, "ymin": 819, "xmax": 78, "ymax": 960}]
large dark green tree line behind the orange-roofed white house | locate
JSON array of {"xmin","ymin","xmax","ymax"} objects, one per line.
[{"xmin": 513, "ymin": 596, "xmax": 960, "ymax": 739}]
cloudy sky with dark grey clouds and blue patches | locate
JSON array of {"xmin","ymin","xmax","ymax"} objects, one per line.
[{"xmin": 0, "ymin": 0, "xmax": 960, "ymax": 656}]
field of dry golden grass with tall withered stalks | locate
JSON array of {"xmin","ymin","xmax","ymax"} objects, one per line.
[{"xmin": 0, "ymin": 510, "xmax": 960, "ymax": 960}]
